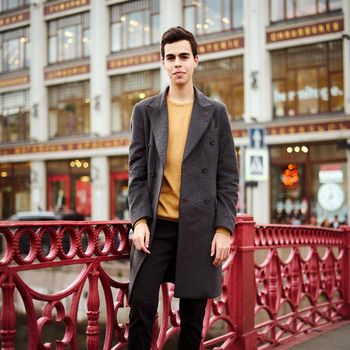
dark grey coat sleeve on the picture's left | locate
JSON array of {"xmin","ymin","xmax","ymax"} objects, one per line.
[{"xmin": 128, "ymin": 105, "xmax": 152, "ymax": 226}]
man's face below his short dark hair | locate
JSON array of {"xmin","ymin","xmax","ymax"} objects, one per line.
[{"xmin": 162, "ymin": 40, "xmax": 198, "ymax": 86}]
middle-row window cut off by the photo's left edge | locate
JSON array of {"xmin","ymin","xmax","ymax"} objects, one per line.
[{"xmin": 0, "ymin": 90, "xmax": 29, "ymax": 142}]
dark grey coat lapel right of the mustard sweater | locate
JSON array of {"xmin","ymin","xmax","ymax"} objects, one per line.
[{"xmin": 183, "ymin": 88, "xmax": 215, "ymax": 161}]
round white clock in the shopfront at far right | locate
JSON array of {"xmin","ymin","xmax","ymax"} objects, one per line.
[{"xmin": 317, "ymin": 183, "xmax": 344, "ymax": 211}]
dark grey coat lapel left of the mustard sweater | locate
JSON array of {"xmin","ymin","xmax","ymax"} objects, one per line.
[{"xmin": 146, "ymin": 89, "xmax": 168, "ymax": 167}]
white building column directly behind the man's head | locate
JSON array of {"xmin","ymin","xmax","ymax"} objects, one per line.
[{"xmin": 159, "ymin": 0, "xmax": 183, "ymax": 91}]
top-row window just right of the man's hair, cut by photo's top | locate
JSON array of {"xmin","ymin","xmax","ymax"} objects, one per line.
[{"xmin": 183, "ymin": 0, "xmax": 243, "ymax": 35}]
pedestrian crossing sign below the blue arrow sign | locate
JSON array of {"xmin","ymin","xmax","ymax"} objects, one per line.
[{"xmin": 245, "ymin": 148, "xmax": 269, "ymax": 181}]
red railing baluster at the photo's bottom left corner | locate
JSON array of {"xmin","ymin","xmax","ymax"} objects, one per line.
[{"xmin": 0, "ymin": 272, "xmax": 16, "ymax": 350}]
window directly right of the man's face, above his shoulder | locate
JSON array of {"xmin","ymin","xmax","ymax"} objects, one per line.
[{"xmin": 194, "ymin": 56, "xmax": 244, "ymax": 120}]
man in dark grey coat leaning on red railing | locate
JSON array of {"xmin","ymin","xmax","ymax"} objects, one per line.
[{"xmin": 128, "ymin": 27, "xmax": 238, "ymax": 350}]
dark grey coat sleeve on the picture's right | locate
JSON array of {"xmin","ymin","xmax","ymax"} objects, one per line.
[{"xmin": 215, "ymin": 105, "xmax": 239, "ymax": 233}]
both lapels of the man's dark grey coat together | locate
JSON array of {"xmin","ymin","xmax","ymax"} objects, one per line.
[{"xmin": 146, "ymin": 87, "xmax": 215, "ymax": 166}]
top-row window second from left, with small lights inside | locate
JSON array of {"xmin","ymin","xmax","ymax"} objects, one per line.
[{"xmin": 48, "ymin": 12, "xmax": 90, "ymax": 63}]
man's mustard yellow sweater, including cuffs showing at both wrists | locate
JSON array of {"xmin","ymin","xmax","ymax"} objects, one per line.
[{"xmin": 136, "ymin": 98, "xmax": 230, "ymax": 235}]
